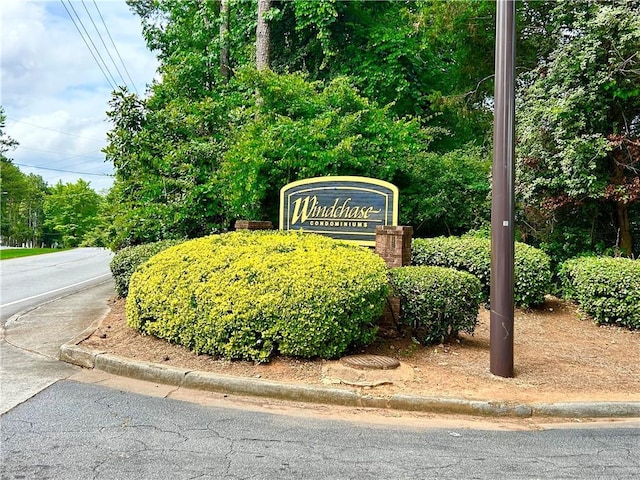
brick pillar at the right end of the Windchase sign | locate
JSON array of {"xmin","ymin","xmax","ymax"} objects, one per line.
[{"xmin": 375, "ymin": 226, "xmax": 413, "ymax": 336}]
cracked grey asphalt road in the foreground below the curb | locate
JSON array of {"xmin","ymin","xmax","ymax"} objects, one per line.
[{"xmin": 0, "ymin": 380, "xmax": 640, "ymax": 480}]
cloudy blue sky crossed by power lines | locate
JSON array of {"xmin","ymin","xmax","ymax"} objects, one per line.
[{"xmin": 0, "ymin": 0, "xmax": 157, "ymax": 191}]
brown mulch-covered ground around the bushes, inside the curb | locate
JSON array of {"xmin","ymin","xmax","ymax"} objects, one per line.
[{"xmin": 82, "ymin": 297, "xmax": 640, "ymax": 403}]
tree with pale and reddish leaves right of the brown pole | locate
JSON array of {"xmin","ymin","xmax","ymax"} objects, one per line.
[{"xmin": 517, "ymin": 2, "xmax": 640, "ymax": 255}]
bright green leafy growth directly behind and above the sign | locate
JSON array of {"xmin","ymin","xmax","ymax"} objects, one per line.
[{"xmin": 218, "ymin": 69, "xmax": 440, "ymax": 223}]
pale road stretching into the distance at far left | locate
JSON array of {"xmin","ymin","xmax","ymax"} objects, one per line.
[{"xmin": 0, "ymin": 248, "xmax": 113, "ymax": 326}]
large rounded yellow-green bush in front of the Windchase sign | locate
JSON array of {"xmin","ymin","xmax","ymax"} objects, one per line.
[{"xmin": 126, "ymin": 231, "xmax": 388, "ymax": 362}]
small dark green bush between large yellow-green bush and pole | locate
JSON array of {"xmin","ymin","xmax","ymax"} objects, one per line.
[{"xmin": 391, "ymin": 267, "xmax": 482, "ymax": 344}]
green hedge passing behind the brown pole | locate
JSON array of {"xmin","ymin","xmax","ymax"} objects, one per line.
[{"xmin": 411, "ymin": 236, "xmax": 551, "ymax": 308}]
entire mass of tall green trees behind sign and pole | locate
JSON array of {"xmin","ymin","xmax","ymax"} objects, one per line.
[{"xmin": 100, "ymin": 0, "xmax": 639, "ymax": 259}]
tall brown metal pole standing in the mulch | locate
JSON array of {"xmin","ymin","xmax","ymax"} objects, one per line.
[{"xmin": 490, "ymin": 0, "xmax": 516, "ymax": 377}]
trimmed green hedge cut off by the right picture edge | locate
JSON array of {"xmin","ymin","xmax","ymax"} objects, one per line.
[{"xmin": 560, "ymin": 257, "xmax": 640, "ymax": 329}]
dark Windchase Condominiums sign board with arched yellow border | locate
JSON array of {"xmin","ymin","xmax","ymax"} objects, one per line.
[{"xmin": 280, "ymin": 177, "xmax": 398, "ymax": 246}]
